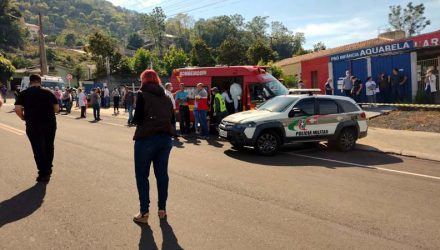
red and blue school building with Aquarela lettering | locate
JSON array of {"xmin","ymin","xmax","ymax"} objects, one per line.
[{"xmin": 275, "ymin": 30, "xmax": 440, "ymax": 101}]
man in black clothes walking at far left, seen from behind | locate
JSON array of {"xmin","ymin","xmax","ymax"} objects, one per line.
[{"xmin": 15, "ymin": 75, "xmax": 60, "ymax": 182}]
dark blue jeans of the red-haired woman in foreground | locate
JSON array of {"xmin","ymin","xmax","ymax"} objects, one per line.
[{"xmin": 134, "ymin": 134, "xmax": 173, "ymax": 214}]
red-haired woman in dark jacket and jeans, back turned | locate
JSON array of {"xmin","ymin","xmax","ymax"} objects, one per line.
[{"xmin": 133, "ymin": 70, "xmax": 174, "ymax": 223}]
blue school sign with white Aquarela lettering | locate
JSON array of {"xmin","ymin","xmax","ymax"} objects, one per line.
[{"xmin": 330, "ymin": 41, "xmax": 414, "ymax": 62}]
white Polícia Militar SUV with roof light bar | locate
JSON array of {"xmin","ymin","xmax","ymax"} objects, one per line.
[{"xmin": 219, "ymin": 95, "xmax": 368, "ymax": 155}]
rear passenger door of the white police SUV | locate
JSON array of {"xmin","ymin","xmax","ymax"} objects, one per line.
[{"xmin": 316, "ymin": 98, "xmax": 344, "ymax": 136}]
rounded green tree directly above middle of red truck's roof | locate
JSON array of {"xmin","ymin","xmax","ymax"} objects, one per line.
[{"xmin": 218, "ymin": 37, "xmax": 246, "ymax": 65}]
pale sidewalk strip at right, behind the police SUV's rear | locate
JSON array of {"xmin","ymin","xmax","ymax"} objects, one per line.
[{"xmin": 357, "ymin": 127, "xmax": 440, "ymax": 161}]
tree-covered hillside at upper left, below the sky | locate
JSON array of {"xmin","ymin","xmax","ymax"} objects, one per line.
[{"xmin": 17, "ymin": 0, "xmax": 141, "ymax": 40}]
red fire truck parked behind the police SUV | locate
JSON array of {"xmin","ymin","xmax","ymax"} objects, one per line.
[{"xmin": 171, "ymin": 66, "xmax": 289, "ymax": 111}]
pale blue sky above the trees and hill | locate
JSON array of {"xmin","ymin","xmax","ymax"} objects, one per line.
[{"xmin": 108, "ymin": 0, "xmax": 440, "ymax": 49}]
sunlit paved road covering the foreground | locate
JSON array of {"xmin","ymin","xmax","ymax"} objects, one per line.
[{"xmin": 0, "ymin": 106, "xmax": 440, "ymax": 249}]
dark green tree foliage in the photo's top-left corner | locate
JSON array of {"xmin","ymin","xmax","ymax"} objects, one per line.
[{"xmin": 0, "ymin": 0, "xmax": 26, "ymax": 51}]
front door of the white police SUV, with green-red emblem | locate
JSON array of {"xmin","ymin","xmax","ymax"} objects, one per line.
[{"xmin": 284, "ymin": 97, "xmax": 317, "ymax": 139}]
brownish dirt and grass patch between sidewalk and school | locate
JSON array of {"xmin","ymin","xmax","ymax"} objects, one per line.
[{"xmin": 370, "ymin": 110, "xmax": 440, "ymax": 133}]
